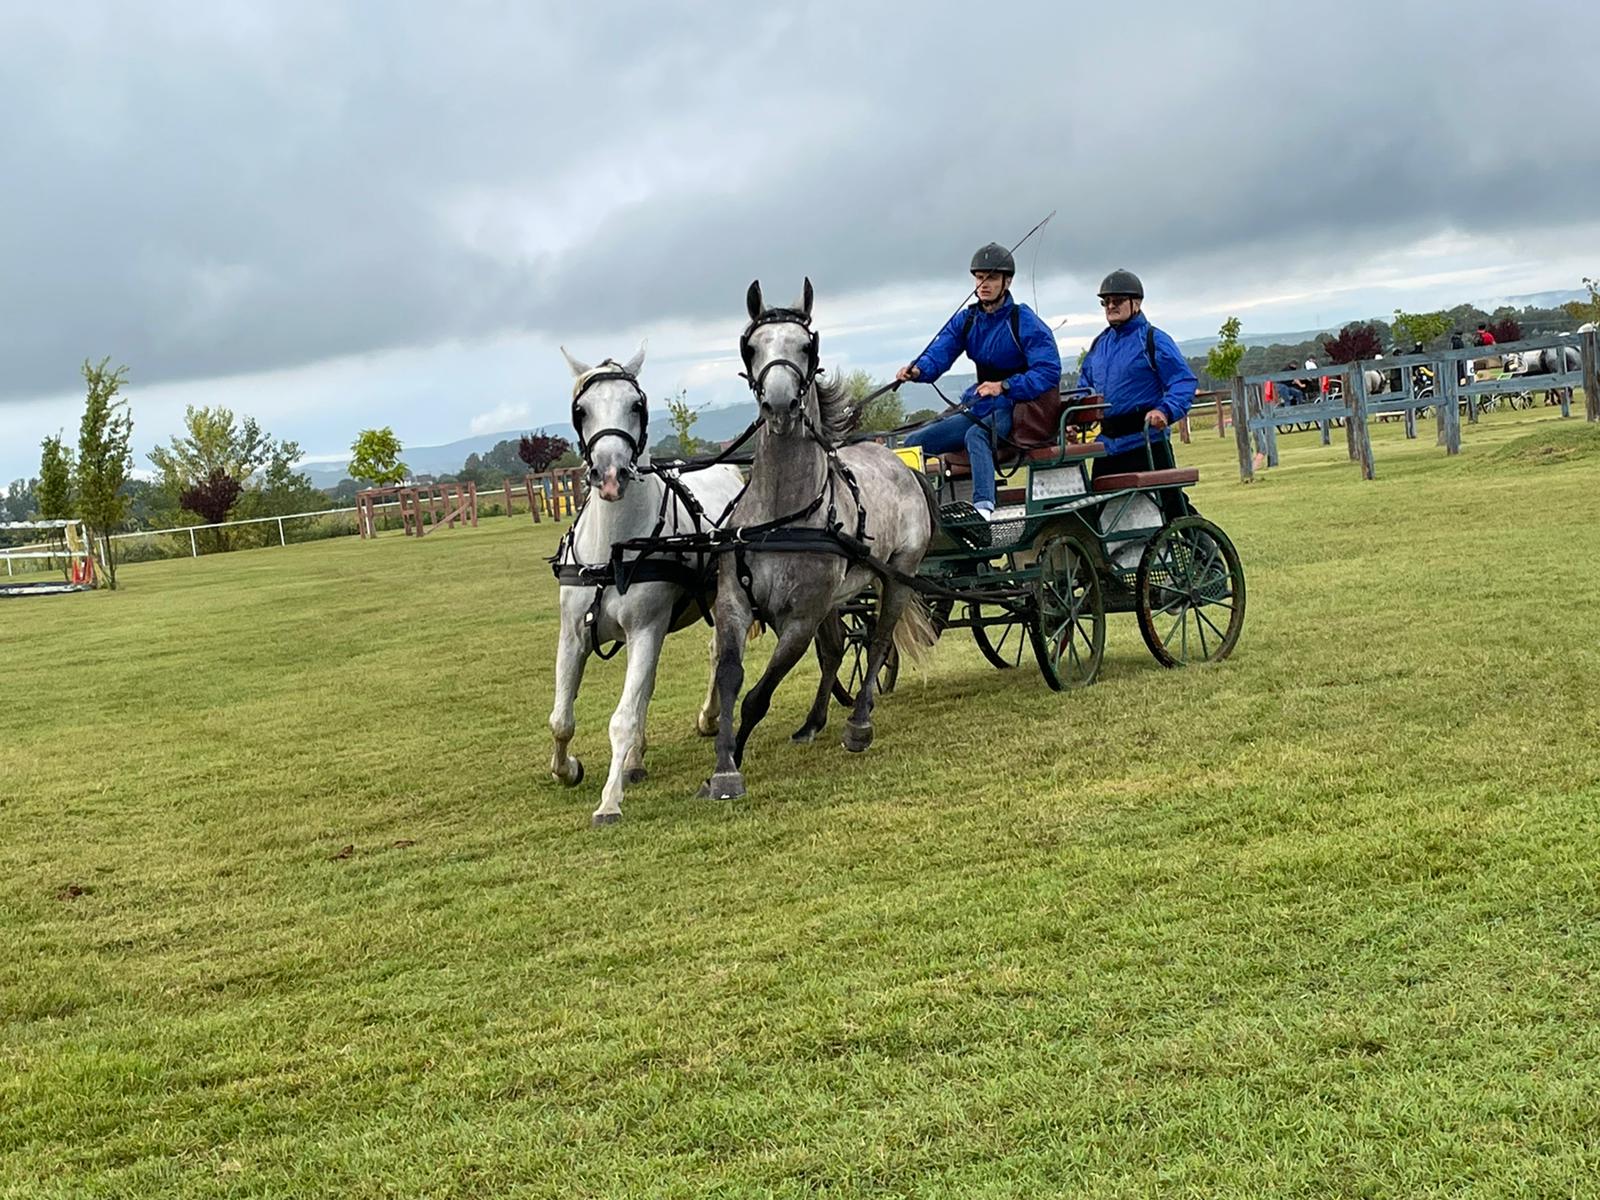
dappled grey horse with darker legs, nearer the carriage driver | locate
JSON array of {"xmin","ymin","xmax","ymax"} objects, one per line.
[{"xmin": 701, "ymin": 280, "xmax": 936, "ymax": 800}]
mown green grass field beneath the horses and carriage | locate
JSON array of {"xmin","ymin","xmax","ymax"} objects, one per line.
[{"xmin": 0, "ymin": 408, "xmax": 1600, "ymax": 1198}]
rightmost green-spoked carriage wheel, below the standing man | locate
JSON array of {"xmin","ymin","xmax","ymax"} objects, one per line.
[{"xmin": 1134, "ymin": 517, "xmax": 1245, "ymax": 667}]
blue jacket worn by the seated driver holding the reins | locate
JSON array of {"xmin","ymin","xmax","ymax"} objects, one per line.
[{"xmin": 914, "ymin": 291, "xmax": 1061, "ymax": 416}]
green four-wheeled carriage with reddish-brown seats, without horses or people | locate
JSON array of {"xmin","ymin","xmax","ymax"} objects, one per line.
[{"xmin": 835, "ymin": 397, "xmax": 1245, "ymax": 704}]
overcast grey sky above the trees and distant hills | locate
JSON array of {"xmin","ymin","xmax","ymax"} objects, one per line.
[{"xmin": 0, "ymin": 0, "xmax": 1600, "ymax": 483}]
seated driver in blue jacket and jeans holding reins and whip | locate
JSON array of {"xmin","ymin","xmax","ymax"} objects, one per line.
[{"xmin": 894, "ymin": 242, "xmax": 1061, "ymax": 517}]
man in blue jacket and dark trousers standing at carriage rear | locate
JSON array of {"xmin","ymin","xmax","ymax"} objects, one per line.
[{"xmin": 1078, "ymin": 270, "xmax": 1197, "ymax": 475}]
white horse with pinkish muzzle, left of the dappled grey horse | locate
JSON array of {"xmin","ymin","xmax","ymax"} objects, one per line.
[{"xmin": 550, "ymin": 346, "xmax": 744, "ymax": 826}]
